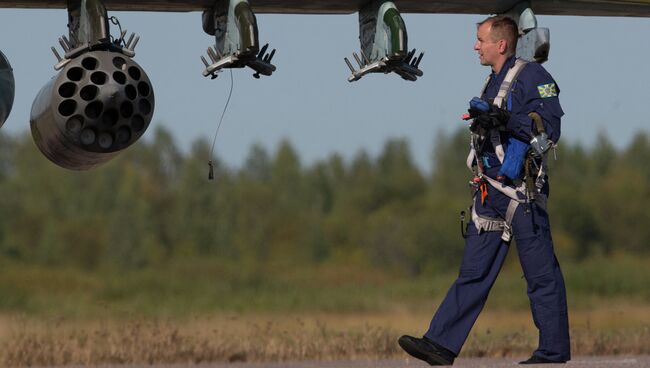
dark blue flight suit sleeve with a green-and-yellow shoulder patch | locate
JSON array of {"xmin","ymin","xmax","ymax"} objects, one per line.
[{"xmin": 507, "ymin": 63, "xmax": 564, "ymax": 143}]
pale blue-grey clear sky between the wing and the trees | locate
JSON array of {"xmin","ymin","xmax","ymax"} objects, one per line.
[{"xmin": 0, "ymin": 9, "xmax": 650, "ymax": 170}]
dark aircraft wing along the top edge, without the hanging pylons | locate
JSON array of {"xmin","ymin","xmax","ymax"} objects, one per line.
[{"xmin": 0, "ymin": 0, "xmax": 650, "ymax": 17}]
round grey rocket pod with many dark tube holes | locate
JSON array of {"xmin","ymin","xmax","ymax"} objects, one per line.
[{"xmin": 30, "ymin": 51, "xmax": 155, "ymax": 170}]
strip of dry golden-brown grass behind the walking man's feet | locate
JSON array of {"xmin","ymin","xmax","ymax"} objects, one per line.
[{"xmin": 0, "ymin": 305, "xmax": 650, "ymax": 366}]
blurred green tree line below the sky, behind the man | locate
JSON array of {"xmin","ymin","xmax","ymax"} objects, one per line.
[{"xmin": 0, "ymin": 128, "xmax": 650, "ymax": 275}]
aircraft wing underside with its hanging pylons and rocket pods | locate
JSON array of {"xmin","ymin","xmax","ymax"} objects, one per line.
[{"xmin": 0, "ymin": 0, "xmax": 650, "ymax": 170}]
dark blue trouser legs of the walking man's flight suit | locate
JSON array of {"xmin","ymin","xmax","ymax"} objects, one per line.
[{"xmin": 425, "ymin": 183, "xmax": 571, "ymax": 361}]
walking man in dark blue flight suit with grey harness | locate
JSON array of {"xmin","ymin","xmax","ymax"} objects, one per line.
[{"xmin": 399, "ymin": 16, "xmax": 571, "ymax": 365}]
